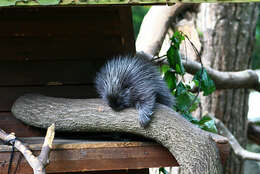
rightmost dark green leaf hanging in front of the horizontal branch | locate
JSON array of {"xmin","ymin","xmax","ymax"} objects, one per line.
[{"xmin": 193, "ymin": 68, "xmax": 216, "ymax": 96}]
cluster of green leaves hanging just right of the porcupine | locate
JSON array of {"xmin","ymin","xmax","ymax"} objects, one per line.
[{"xmin": 161, "ymin": 31, "xmax": 217, "ymax": 133}]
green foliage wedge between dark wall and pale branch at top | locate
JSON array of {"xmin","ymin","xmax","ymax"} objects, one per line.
[{"xmin": 132, "ymin": 6, "xmax": 150, "ymax": 38}]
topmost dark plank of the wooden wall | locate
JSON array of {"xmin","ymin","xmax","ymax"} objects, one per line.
[{"xmin": 0, "ymin": 7, "xmax": 121, "ymax": 37}]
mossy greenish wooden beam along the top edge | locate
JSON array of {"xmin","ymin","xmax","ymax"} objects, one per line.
[{"xmin": 0, "ymin": 0, "xmax": 259, "ymax": 7}]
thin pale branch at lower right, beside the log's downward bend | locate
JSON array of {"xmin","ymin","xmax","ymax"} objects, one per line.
[{"xmin": 212, "ymin": 117, "xmax": 260, "ymax": 161}]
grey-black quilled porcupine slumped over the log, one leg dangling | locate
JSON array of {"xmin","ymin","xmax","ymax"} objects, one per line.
[{"xmin": 95, "ymin": 56, "xmax": 175, "ymax": 127}]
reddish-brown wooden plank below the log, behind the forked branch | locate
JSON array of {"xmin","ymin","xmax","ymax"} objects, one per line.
[{"xmin": 0, "ymin": 138, "xmax": 178, "ymax": 174}]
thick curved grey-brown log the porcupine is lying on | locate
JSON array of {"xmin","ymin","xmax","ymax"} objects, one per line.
[{"xmin": 12, "ymin": 94, "xmax": 222, "ymax": 174}]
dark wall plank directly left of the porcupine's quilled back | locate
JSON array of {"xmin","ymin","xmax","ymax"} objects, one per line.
[{"xmin": 0, "ymin": 60, "xmax": 105, "ymax": 87}]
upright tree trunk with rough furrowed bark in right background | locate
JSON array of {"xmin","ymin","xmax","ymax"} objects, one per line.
[{"xmin": 196, "ymin": 3, "xmax": 258, "ymax": 174}]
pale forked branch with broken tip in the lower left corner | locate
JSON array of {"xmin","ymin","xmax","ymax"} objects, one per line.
[{"xmin": 0, "ymin": 124, "xmax": 55, "ymax": 174}]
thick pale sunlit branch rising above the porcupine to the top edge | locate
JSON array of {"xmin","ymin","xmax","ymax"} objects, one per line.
[{"xmin": 136, "ymin": 3, "xmax": 192, "ymax": 55}]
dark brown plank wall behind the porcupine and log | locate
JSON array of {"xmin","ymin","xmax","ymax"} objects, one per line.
[{"xmin": 0, "ymin": 7, "xmax": 135, "ymax": 137}]
